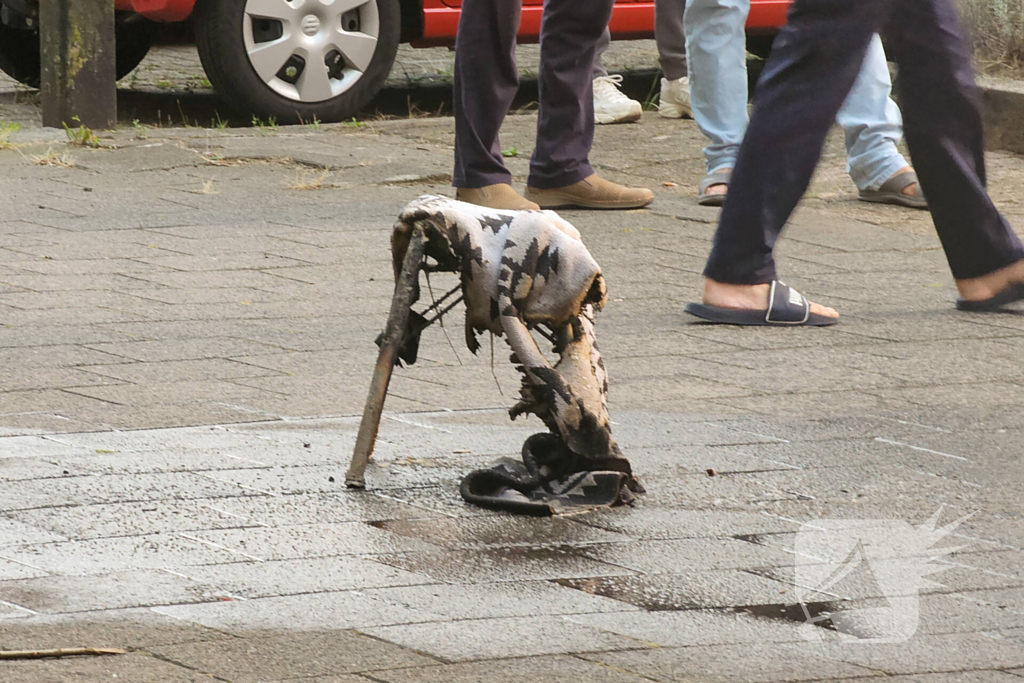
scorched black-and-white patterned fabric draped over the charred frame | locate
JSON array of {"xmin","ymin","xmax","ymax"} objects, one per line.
[{"xmin": 391, "ymin": 196, "xmax": 642, "ymax": 515}]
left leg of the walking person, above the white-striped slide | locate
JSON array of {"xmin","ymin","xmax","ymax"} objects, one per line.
[{"xmin": 690, "ymin": 0, "xmax": 892, "ymax": 300}]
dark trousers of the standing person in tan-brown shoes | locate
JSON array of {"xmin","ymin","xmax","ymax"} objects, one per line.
[{"xmin": 452, "ymin": 0, "xmax": 614, "ymax": 188}]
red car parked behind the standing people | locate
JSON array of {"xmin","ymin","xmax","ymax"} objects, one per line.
[{"xmin": 0, "ymin": 0, "xmax": 790, "ymax": 123}]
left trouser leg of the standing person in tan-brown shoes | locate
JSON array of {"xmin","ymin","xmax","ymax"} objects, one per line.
[{"xmin": 452, "ymin": 0, "xmax": 521, "ymax": 188}]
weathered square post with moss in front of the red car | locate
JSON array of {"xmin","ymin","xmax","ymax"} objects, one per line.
[{"xmin": 39, "ymin": 0, "xmax": 118, "ymax": 128}]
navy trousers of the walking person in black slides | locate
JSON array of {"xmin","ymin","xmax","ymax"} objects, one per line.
[{"xmin": 705, "ymin": 0, "xmax": 1024, "ymax": 285}]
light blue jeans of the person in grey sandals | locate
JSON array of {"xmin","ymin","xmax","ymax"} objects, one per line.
[{"xmin": 677, "ymin": 0, "xmax": 909, "ymax": 189}]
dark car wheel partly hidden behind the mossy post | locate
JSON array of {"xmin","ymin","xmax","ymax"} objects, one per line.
[{"xmin": 0, "ymin": 12, "xmax": 156, "ymax": 88}]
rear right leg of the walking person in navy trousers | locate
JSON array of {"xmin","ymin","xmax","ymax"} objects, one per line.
[{"xmin": 887, "ymin": 0, "xmax": 1024, "ymax": 288}]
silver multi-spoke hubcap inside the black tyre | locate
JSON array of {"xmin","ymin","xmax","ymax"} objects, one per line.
[{"xmin": 243, "ymin": 0, "xmax": 380, "ymax": 102}]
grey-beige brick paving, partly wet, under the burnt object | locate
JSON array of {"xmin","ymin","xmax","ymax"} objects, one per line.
[{"xmin": 0, "ymin": 93, "xmax": 1024, "ymax": 683}]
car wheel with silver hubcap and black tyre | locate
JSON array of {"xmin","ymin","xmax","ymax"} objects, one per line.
[{"xmin": 196, "ymin": 0, "xmax": 401, "ymax": 123}]
